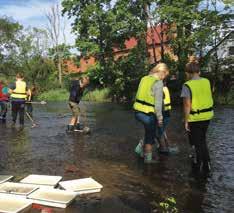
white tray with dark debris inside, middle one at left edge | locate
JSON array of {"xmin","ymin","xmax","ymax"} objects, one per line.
[{"xmin": 0, "ymin": 182, "xmax": 39, "ymax": 197}]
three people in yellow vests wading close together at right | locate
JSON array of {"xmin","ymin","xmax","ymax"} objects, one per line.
[{"xmin": 133, "ymin": 57, "xmax": 214, "ymax": 172}]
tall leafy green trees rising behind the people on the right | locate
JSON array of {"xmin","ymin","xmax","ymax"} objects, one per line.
[{"xmin": 63, "ymin": 0, "xmax": 230, "ymax": 101}]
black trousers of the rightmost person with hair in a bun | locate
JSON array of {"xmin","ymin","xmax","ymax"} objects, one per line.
[{"xmin": 189, "ymin": 121, "xmax": 210, "ymax": 166}]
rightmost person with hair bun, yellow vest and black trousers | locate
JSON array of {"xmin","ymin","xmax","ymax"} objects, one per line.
[{"xmin": 181, "ymin": 58, "xmax": 214, "ymax": 172}]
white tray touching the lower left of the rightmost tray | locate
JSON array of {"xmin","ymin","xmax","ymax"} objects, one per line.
[{"xmin": 27, "ymin": 189, "xmax": 77, "ymax": 208}]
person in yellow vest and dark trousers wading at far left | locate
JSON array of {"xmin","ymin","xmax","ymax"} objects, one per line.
[{"xmin": 9, "ymin": 73, "xmax": 31, "ymax": 127}]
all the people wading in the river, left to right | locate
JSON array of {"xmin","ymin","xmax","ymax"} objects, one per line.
[{"xmin": 0, "ymin": 59, "xmax": 214, "ymax": 175}]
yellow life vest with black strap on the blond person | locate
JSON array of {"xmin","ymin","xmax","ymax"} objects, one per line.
[{"xmin": 133, "ymin": 75, "xmax": 159, "ymax": 113}]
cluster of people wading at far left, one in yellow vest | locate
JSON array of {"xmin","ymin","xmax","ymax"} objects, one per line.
[{"xmin": 0, "ymin": 73, "xmax": 36, "ymax": 127}]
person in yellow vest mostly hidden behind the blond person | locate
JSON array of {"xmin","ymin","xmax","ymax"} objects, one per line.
[{"xmin": 157, "ymin": 81, "xmax": 171, "ymax": 154}]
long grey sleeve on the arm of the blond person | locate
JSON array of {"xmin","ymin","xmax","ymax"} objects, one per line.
[{"xmin": 152, "ymin": 80, "xmax": 163, "ymax": 120}]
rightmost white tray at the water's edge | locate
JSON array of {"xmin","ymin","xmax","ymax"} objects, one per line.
[{"xmin": 59, "ymin": 178, "xmax": 103, "ymax": 194}]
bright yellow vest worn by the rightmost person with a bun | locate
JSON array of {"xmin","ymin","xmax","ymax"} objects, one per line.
[{"xmin": 185, "ymin": 78, "xmax": 214, "ymax": 122}]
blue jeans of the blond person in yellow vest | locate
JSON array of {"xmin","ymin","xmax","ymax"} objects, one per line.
[{"xmin": 135, "ymin": 112, "xmax": 157, "ymax": 144}]
